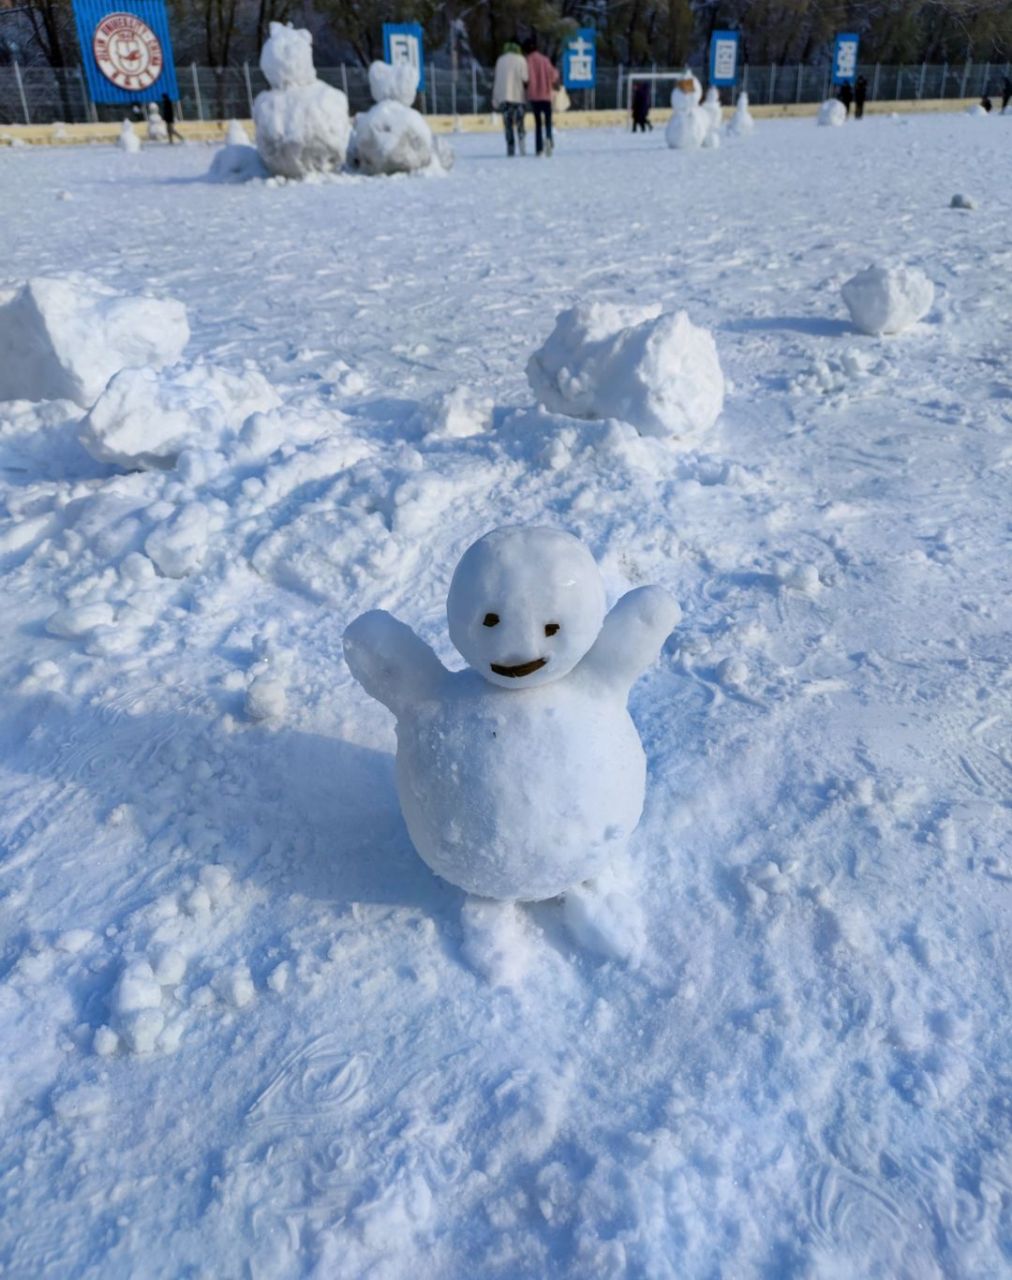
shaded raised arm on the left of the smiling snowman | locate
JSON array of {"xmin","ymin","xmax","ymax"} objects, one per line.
[{"xmin": 344, "ymin": 609, "xmax": 448, "ymax": 716}]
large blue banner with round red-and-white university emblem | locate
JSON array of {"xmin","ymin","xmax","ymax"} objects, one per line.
[{"xmin": 74, "ymin": 0, "xmax": 179, "ymax": 102}]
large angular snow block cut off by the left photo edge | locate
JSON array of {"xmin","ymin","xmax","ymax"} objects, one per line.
[{"xmin": 0, "ymin": 276, "xmax": 189, "ymax": 408}]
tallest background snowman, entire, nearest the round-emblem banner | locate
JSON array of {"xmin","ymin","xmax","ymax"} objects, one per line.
[{"xmin": 253, "ymin": 22, "xmax": 351, "ymax": 178}]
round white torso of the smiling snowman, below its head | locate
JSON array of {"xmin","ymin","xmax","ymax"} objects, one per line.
[{"xmin": 397, "ymin": 668, "xmax": 646, "ymax": 900}]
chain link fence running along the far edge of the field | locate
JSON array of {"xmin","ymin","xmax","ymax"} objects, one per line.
[{"xmin": 0, "ymin": 63, "xmax": 1012, "ymax": 124}]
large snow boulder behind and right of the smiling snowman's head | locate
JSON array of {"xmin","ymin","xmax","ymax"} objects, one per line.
[{"xmin": 527, "ymin": 302, "xmax": 724, "ymax": 443}]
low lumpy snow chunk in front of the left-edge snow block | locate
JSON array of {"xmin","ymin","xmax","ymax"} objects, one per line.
[{"xmin": 81, "ymin": 364, "xmax": 280, "ymax": 471}]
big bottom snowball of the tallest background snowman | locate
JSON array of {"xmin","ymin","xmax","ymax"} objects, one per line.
[{"xmin": 253, "ymin": 81, "xmax": 352, "ymax": 178}]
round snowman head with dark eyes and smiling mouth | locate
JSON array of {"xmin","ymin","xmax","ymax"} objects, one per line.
[{"xmin": 447, "ymin": 526, "xmax": 605, "ymax": 689}]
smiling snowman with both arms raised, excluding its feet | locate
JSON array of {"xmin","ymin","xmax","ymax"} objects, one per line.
[{"xmin": 344, "ymin": 527, "xmax": 681, "ymax": 901}]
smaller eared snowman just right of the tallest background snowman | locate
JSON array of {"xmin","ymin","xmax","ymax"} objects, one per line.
[{"xmin": 348, "ymin": 63, "xmax": 453, "ymax": 174}]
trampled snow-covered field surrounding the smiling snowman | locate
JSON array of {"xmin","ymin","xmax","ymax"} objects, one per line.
[{"xmin": 0, "ymin": 115, "xmax": 1012, "ymax": 1280}]
